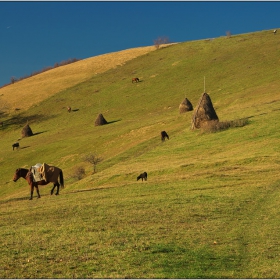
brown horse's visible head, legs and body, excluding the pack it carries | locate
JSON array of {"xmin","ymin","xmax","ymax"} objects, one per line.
[{"xmin": 13, "ymin": 168, "xmax": 64, "ymax": 200}]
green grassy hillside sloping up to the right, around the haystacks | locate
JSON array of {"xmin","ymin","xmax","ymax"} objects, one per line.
[{"xmin": 0, "ymin": 31, "xmax": 280, "ymax": 278}]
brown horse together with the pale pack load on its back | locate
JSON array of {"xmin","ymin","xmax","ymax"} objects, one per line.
[{"xmin": 13, "ymin": 163, "xmax": 64, "ymax": 200}]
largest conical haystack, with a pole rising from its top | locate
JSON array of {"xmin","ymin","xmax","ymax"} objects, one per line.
[{"xmin": 192, "ymin": 93, "xmax": 219, "ymax": 129}]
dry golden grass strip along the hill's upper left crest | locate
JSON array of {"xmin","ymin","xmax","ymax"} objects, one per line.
[{"xmin": 0, "ymin": 46, "xmax": 164, "ymax": 113}]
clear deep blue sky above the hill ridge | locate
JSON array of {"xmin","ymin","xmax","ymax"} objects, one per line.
[{"xmin": 0, "ymin": 1, "xmax": 280, "ymax": 86}]
